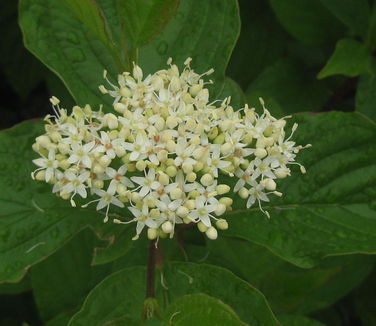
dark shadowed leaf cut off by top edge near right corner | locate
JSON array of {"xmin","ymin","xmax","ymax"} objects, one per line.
[{"xmin": 321, "ymin": 0, "xmax": 370, "ymax": 36}]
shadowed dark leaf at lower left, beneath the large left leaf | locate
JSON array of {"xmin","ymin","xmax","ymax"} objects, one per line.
[{"xmin": 30, "ymin": 230, "xmax": 110, "ymax": 321}]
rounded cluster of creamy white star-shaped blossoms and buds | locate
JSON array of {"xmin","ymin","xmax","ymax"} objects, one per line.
[{"xmin": 32, "ymin": 58, "xmax": 305, "ymax": 239}]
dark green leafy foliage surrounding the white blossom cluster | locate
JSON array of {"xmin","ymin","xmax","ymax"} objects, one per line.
[{"xmin": 0, "ymin": 0, "xmax": 376, "ymax": 326}]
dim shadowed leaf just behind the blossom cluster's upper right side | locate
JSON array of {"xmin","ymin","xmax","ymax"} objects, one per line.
[{"xmin": 246, "ymin": 59, "xmax": 329, "ymax": 117}]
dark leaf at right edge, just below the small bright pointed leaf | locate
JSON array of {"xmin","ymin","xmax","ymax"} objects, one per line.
[{"xmin": 355, "ymin": 74, "xmax": 376, "ymax": 120}]
